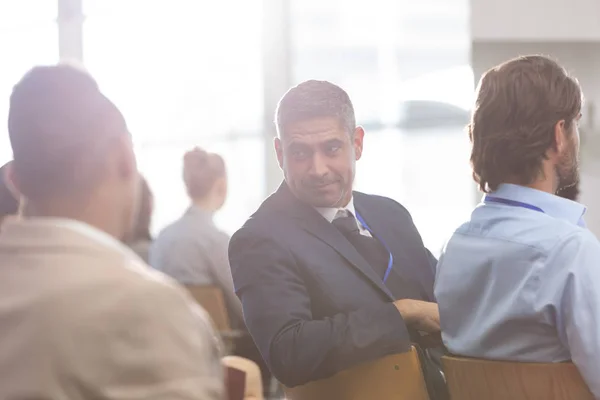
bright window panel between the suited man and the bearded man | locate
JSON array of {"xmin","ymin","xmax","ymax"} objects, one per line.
[{"xmin": 291, "ymin": 0, "xmax": 475, "ymax": 254}]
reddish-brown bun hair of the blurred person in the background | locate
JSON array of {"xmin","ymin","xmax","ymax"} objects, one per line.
[{"xmin": 183, "ymin": 147, "xmax": 226, "ymax": 199}]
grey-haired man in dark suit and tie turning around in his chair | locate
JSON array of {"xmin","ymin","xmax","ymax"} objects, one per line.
[{"xmin": 229, "ymin": 81, "xmax": 440, "ymax": 396}]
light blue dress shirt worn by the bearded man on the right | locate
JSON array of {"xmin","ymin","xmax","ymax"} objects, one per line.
[{"xmin": 435, "ymin": 184, "xmax": 600, "ymax": 399}]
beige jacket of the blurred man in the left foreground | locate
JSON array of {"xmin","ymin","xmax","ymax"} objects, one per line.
[{"xmin": 0, "ymin": 218, "xmax": 224, "ymax": 400}]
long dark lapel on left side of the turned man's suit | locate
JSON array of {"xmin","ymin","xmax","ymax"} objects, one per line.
[{"xmin": 270, "ymin": 183, "xmax": 394, "ymax": 300}]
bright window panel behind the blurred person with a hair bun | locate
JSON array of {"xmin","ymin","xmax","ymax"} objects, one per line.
[{"xmin": 83, "ymin": 0, "xmax": 265, "ymax": 232}]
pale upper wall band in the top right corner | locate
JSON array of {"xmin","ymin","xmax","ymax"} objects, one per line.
[{"xmin": 470, "ymin": 0, "xmax": 600, "ymax": 41}]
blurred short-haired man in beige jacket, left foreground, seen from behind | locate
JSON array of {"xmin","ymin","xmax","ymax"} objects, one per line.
[{"xmin": 0, "ymin": 65, "xmax": 224, "ymax": 400}]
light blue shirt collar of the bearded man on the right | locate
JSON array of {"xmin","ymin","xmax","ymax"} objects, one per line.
[{"xmin": 491, "ymin": 183, "xmax": 586, "ymax": 225}]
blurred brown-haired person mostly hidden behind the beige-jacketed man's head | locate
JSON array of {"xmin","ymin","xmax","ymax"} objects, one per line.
[{"xmin": 125, "ymin": 176, "xmax": 154, "ymax": 263}]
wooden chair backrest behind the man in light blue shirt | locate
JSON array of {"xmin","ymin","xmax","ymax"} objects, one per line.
[{"xmin": 442, "ymin": 356, "xmax": 594, "ymax": 400}]
